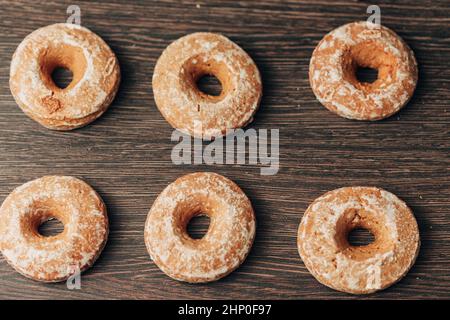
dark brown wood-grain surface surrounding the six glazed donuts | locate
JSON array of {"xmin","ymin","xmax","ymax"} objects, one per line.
[{"xmin": 0, "ymin": 0, "xmax": 450, "ymax": 299}]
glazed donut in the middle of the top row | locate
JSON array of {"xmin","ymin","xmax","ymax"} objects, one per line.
[{"xmin": 152, "ymin": 33, "xmax": 262, "ymax": 140}]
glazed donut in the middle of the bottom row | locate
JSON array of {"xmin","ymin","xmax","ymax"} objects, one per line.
[{"xmin": 145, "ymin": 172, "xmax": 255, "ymax": 283}]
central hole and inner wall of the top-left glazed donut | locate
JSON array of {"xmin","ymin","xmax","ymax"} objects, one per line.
[{"xmin": 39, "ymin": 45, "xmax": 87, "ymax": 92}]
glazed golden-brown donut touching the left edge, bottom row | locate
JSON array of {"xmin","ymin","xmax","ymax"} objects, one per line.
[{"xmin": 0, "ymin": 176, "xmax": 108, "ymax": 282}]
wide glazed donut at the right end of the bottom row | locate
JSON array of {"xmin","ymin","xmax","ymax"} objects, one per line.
[{"xmin": 298, "ymin": 187, "xmax": 420, "ymax": 294}]
